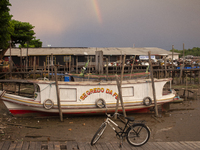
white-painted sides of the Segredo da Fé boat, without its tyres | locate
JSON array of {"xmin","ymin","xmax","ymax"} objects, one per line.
[{"xmin": 0, "ymin": 79, "xmax": 175, "ymax": 116}]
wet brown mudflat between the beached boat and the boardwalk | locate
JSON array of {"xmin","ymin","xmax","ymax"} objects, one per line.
[{"xmin": 0, "ymin": 89, "xmax": 200, "ymax": 142}]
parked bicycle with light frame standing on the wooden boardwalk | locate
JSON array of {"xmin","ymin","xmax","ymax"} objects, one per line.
[{"xmin": 91, "ymin": 113, "xmax": 150, "ymax": 147}]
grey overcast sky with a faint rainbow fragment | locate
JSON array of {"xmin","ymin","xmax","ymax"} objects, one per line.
[{"xmin": 10, "ymin": 0, "xmax": 200, "ymax": 50}]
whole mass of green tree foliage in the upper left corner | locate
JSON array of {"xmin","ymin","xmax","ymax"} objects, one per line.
[{"xmin": 0, "ymin": 0, "xmax": 42, "ymax": 60}]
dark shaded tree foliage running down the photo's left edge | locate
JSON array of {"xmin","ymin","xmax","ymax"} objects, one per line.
[{"xmin": 0, "ymin": 0, "xmax": 13, "ymax": 60}]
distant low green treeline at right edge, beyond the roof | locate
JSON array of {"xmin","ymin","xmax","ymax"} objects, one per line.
[{"xmin": 170, "ymin": 47, "xmax": 200, "ymax": 57}]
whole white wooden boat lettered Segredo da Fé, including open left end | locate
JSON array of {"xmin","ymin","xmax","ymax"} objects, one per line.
[{"xmin": 0, "ymin": 78, "xmax": 175, "ymax": 116}]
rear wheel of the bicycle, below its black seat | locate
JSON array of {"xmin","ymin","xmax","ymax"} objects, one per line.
[{"xmin": 126, "ymin": 124, "xmax": 150, "ymax": 147}]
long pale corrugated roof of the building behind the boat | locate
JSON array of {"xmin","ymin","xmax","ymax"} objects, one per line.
[{"xmin": 5, "ymin": 47, "xmax": 178, "ymax": 56}]
